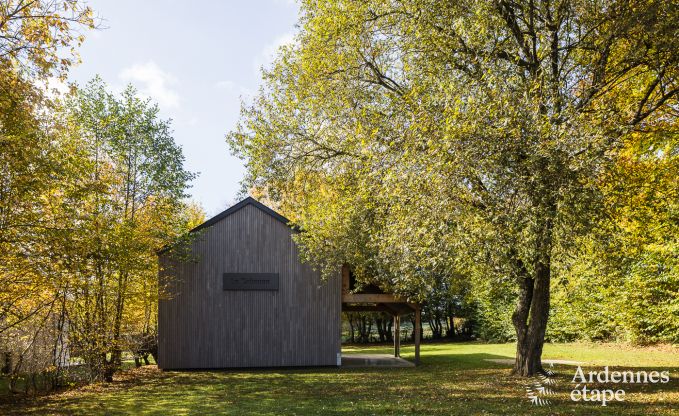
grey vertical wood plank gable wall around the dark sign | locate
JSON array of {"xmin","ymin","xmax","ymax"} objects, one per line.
[{"xmin": 158, "ymin": 205, "xmax": 341, "ymax": 369}]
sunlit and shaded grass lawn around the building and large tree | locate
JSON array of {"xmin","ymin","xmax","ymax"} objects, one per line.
[{"xmin": 0, "ymin": 343, "xmax": 679, "ymax": 415}]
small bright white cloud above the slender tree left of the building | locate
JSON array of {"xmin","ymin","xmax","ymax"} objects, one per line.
[{"xmin": 119, "ymin": 61, "xmax": 179, "ymax": 109}]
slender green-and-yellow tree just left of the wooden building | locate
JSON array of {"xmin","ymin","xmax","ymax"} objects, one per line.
[{"xmin": 61, "ymin": 78, "xmax": 194, "ymax": 381}]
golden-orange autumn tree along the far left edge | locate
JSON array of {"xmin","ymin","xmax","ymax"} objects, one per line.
[{"xmin": 0, "ymin": 0, "xmax": 94, "ymax": 391}]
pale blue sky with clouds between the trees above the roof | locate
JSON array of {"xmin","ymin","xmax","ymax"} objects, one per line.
[{"xmin": 69, "ymin": 0, "xmax": 298, "ymax": 216}]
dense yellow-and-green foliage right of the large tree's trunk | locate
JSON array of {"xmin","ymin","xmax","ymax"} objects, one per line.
[{"xmin": 548, "ymin": 125, "xmax": 679, "ymax": 343}]
